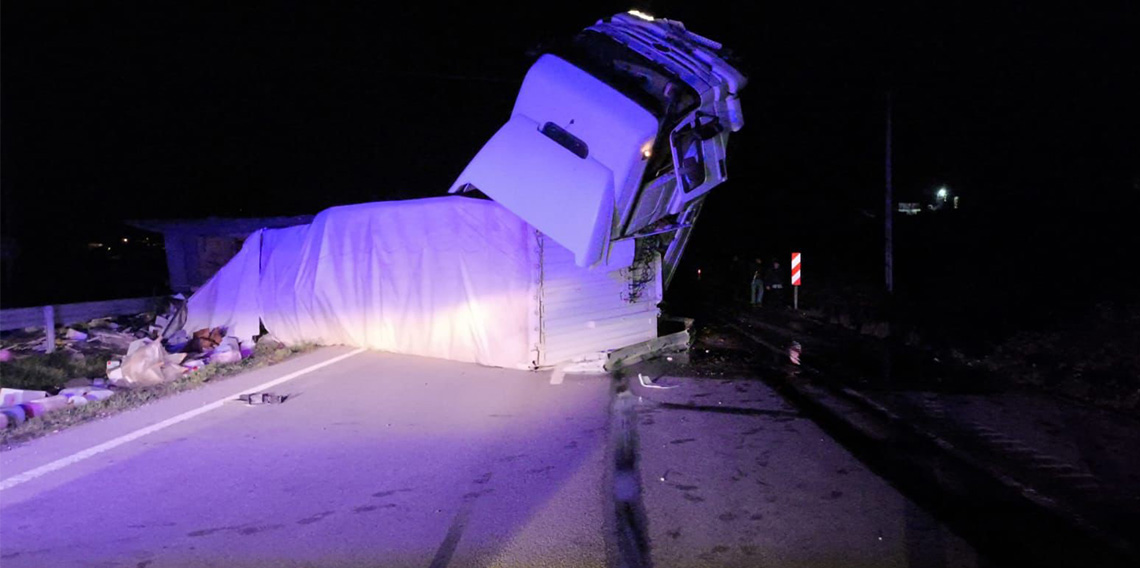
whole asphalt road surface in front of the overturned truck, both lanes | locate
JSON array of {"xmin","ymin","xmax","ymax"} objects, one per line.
[{"xmin": 0, "ymin": 349, "xmax": 979, "ymax": 568}]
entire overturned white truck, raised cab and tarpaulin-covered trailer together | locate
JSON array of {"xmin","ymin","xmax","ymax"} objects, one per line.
[{"xmin": 186, "ymin": 13, "xmax": 744, "ymax": 368}]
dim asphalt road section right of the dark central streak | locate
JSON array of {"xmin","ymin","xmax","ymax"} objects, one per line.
[{"xmin": 633, "ymin": 370, "xmax": 991, "ymax": 568}]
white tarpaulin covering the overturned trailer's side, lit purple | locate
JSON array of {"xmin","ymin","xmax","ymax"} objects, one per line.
[{"xmin": 186, "ymin": 197, "xmax": 537, "ymax": 367}]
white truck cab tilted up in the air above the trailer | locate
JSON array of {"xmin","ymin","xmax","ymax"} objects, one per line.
[{"xmin": 450, "ymin": 11, "xmax": 746, "ymax": 285}]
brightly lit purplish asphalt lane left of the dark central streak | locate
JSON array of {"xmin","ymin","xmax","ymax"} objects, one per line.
[{"xmin": 0, "ymin": 350, "xmax": 612, "ymax": 568}]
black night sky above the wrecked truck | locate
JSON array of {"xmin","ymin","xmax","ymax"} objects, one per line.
[{"xmin": 0, "ymin": 0, "xmax": 1140, "ymax": 306}]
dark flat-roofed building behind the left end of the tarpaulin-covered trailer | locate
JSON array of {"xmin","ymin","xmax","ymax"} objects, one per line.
[{"xmin": 127, "ymin": 216, "xmax": 312, "ymax": 293}]
